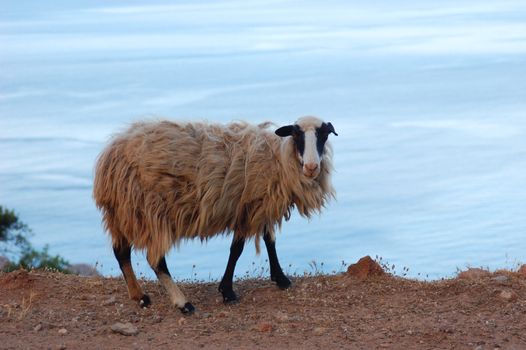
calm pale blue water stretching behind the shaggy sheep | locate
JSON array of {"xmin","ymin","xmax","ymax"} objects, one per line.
[{"xmin": 0, "ymin": 0, "xmax": 526, "ymax": 279}]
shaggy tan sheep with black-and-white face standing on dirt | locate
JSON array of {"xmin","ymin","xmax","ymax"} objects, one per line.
[{"xmin": 93, "ymin": 117, "xmax": 337, "ymax": 314}]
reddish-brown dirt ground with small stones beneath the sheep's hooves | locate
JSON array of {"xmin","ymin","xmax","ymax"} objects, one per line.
[{"xmin": 0, "ymin": 258, "xmax": 526, "ymax": 350}]
